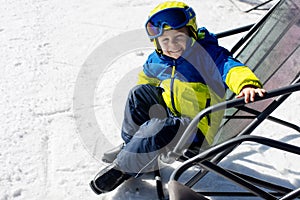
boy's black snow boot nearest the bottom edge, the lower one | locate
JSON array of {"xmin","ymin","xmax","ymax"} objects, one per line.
[{"xmin": 90, "ymin": 163, "xmax": 131, "ymax": 195}]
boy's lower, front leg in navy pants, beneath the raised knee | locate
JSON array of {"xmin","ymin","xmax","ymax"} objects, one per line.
[{"xmin": 114, "ymin": 117, "xmax": 190, "ymax": 176}]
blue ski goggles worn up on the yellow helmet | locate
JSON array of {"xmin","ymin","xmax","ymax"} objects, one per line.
[{"xmin": 145, "ymin": 8, "xmax": 196, "ymax": 39}]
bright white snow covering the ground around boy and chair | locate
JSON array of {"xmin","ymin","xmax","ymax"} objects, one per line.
[{"xmin": 0, "ymin": 0, "xmax": 300, "ymax": 200}]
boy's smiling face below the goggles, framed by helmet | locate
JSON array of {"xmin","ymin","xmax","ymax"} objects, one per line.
[{"xmin": 157, "ymin": 27, "xmax": 189, "ymax": 59}]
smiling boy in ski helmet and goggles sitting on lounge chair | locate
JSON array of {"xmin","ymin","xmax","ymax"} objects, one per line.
[{"xmin": 90, "ymin": 1, "xmax": 265, "ymax": 194}]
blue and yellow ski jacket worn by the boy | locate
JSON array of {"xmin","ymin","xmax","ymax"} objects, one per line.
[{"xmin": 138, "ymin": 28, "xmax": 262, "ymax": 142}]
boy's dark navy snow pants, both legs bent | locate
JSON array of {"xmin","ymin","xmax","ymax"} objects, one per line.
[{"xmin": 115, "ymin": 85, "xmax": 203, "ymax": 175}]
